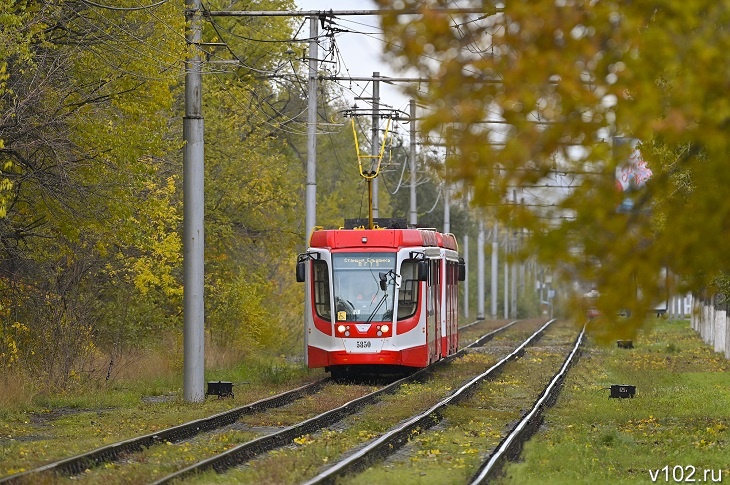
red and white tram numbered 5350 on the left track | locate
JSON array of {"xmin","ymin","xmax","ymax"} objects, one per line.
[{"xmin": 297, "ymin": 220, "xmax": 465, "ymax": 377}]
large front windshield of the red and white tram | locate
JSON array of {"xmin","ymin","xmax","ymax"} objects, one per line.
[{"xmin": 332, "ymin": 253, "xmax": 396, "ymax": 322}]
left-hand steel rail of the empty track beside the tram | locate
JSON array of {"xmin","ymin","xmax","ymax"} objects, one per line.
[{"xmin": 304, "ymin": 319, "xmax": 555, "ymax": 485}]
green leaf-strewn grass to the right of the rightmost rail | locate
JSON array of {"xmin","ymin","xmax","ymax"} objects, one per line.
[{"xmin": 499, "ymin": 319, "xmax": 730, "ymax": 485}]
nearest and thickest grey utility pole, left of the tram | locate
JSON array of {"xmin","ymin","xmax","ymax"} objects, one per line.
[{"xmin": 183, "ymin": 0, "xmax": 205, "ymax": 402}]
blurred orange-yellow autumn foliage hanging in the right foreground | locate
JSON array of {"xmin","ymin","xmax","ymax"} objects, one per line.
[{"xmin": 378, "ymin": 0, "xmax": 730, "ymax": 338}]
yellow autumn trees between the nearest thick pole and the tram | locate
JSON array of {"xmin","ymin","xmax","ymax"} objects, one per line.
[{"xmin": 191, "ymin": 1, "xmax": 306, "ymax": 354}]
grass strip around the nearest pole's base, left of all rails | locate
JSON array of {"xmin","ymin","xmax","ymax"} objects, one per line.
[{"xmin": 0, "ymin": 362, "xmax": 326, "ymax": 476}]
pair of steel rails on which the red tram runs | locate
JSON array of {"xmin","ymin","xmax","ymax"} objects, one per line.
[{"xmin": 0, "ymin": 316, "xmax": 516, "ymax": 484}]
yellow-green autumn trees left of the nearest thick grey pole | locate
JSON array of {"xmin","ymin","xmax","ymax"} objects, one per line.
[{"xmin": 0, "ymin": 1, "xmax": 184, "ymax": 385}]
